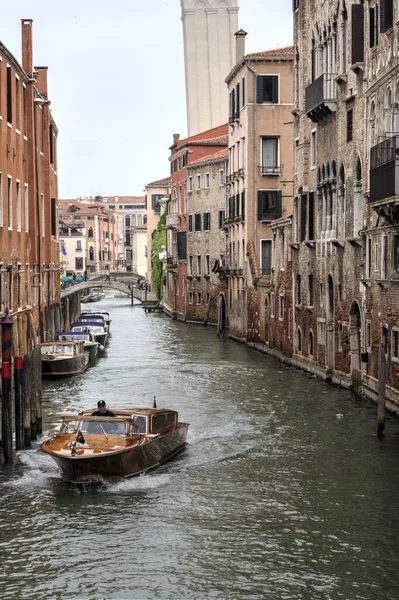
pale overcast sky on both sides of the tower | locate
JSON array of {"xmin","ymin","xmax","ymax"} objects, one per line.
[{"xmin": 0, "ymin": 0, "xmax": 292, "ymax": 198}]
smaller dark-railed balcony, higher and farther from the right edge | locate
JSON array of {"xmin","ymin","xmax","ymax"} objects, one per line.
[{"xmin": 305, "ymin": 73, "xmax": 337, "ymax": 123}]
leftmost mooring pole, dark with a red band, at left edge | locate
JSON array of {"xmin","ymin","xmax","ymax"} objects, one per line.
[{"xmin": 0, "ymin": 308, "xmax": 13, "ymax": 463}]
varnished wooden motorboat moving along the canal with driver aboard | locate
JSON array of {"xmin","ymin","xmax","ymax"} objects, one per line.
[{"xmin": 40, "ymin": 407, "xmax": 189, "ymax": 482}]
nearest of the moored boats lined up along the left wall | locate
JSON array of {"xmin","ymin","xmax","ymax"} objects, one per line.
[{"xmin": 38, "ymin": 341, "xmax": 89, "ymax": 377}]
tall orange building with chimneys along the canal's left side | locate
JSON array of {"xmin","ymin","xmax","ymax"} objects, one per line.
[{"xmin": 0, "ymin": 19, "xmax": 60, "ymax": 346}]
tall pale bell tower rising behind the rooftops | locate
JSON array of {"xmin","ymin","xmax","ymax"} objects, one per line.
[{"xmin": 180, "ymin": 0, "xmax": 239, "ymax": 136}]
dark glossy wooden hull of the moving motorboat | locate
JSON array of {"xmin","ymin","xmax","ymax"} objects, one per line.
[{"xmin": 41, "ymin": 423, "xmax": 188, "ymax": 482}]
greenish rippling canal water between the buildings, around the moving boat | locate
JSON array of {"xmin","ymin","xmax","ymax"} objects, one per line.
[{"xmin": 0, "ymin": 298, "xmax": 399, "ymax": 600}]
